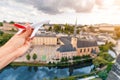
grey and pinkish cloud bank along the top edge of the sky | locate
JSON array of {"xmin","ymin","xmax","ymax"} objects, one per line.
[{"xmin": 11, "ymin": 0, "xmax": 120, "ymax": 15}]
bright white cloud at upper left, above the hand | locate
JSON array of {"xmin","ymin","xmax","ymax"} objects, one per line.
[{"xmin": 0, "ymin": 0, "xmax": 48, "ymax": 21}]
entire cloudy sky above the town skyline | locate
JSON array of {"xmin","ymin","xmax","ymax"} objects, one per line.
[{"xmin": 0, "ymin": 0, "xmax": 120, "ymax": 24}]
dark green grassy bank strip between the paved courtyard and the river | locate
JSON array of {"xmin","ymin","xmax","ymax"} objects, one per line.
[{"xmin": 9, "ymin": 58, "xmax": 92, "ymax": 67}]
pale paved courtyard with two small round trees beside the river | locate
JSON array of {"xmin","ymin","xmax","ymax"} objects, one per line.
[{"xmin": 14, "ymin": 46, "xmax": 59, "ymax": 62}]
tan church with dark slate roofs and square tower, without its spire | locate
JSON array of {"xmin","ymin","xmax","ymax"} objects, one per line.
[{"xmin": 58, "ymin": 37, "xmax": 99, "ymax": 57}]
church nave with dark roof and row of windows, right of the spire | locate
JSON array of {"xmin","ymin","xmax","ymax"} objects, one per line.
[{"xmin": 77, "ymin": 40, "xmax": 99, "ymax": 56}]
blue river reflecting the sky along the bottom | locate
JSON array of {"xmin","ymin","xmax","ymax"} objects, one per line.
[{"xmin": 0, "ymin": 65, "xmax": 94, "ymax": 80}]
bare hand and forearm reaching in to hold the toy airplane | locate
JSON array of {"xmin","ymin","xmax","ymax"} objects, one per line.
[{"xmin": 0, "ymin": 26, "xmax": 33, "ymax": 69}]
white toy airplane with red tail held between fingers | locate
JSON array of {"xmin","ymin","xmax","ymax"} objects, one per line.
[{"xmin": 14, "ymin": 20, "xmax": 50, "ymax": 38}]
